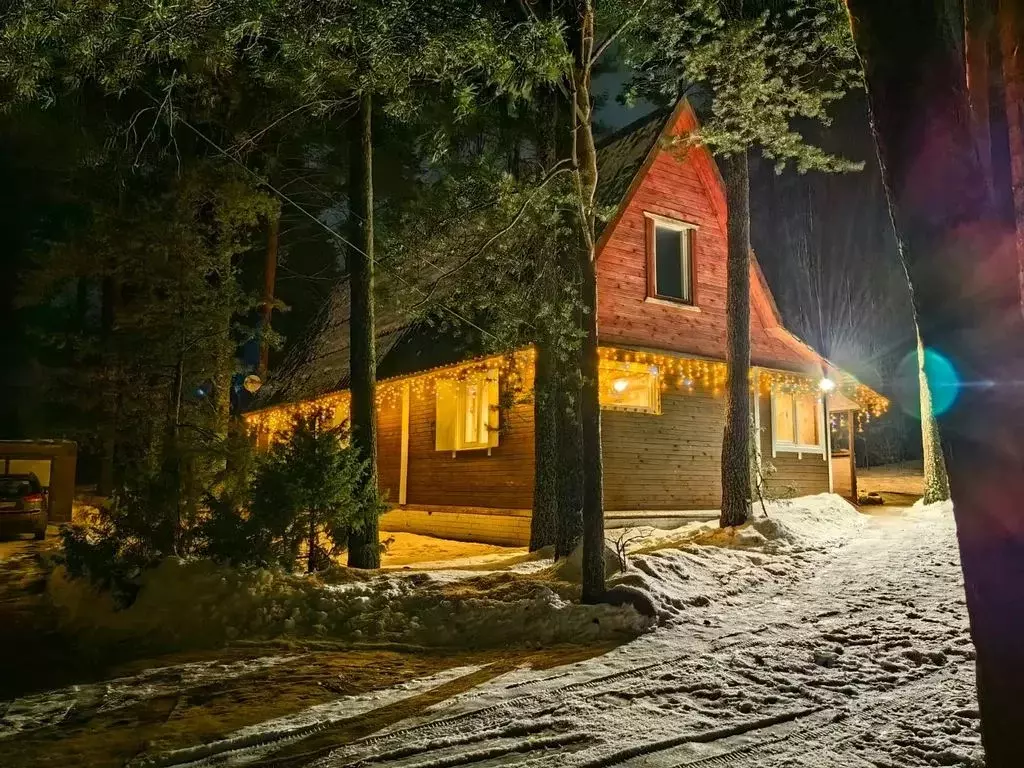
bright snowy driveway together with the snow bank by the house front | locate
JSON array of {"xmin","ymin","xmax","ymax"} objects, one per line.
[{"xmin": 41, "ymin": 497, "xmax": 966, "ymax": 768}]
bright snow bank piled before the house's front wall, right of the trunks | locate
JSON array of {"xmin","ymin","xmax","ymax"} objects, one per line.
[{"xmin": 609, "ymin": 494, "xmax": 866, "ymax": 624}]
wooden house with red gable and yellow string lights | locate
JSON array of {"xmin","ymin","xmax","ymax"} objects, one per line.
[{"xmin": 248, "ymin": 102, "xmax": 887, "ymax": 544}]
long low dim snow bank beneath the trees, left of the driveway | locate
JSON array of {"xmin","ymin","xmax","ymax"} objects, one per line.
[{"xmin": 49, "ymin": 558, "xmax": 649, "ymax": 648}]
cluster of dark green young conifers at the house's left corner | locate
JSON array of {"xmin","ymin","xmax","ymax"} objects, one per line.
[{"xmin": 61, "ymin": 409, "xmax": 383, "ymax": 606}]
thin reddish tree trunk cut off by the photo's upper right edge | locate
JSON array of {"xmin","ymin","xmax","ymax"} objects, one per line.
[{"xmin": 998, "ymin": 0, "xmax": 1024, "ymax": 313}]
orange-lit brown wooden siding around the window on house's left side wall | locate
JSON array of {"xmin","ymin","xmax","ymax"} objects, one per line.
[{"xmin": 395, "ymin": 389, "xmax": 534, "ymax": 509}]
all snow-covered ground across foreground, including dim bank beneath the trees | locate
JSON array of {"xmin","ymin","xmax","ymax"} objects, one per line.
[{"xmin": 9, "ymin": 495, "xmax": 983, "ymax": 768}]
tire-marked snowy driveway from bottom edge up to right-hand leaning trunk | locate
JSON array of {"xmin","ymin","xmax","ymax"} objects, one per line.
[{"xmin": 278, "ymin": 511, "xmax": 983, "ymax": 768}]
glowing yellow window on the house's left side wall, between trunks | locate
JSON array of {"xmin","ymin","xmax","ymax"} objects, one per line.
[{"xmin": 434, "ymin": 370, "xmax": 499, "ymax": 452}]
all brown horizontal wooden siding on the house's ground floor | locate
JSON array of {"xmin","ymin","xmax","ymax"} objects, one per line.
[{"xmin": 378, "ymin": 372, "xmax": 828, "ymax": 518}]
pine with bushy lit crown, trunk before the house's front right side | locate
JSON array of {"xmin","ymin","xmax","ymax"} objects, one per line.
[{"xmin": 624, "ymin": 0, "xmax": 857, "ymax": 525}]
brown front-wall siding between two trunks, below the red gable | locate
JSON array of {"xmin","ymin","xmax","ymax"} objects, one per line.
[{"xmin": 601, "ymin": 391, "xmax": 725, "ymax": 511}]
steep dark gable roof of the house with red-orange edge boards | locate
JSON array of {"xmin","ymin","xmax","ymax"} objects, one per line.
[{"xmin": 249, "ymin": 105, "xmax": 827, "ymax": 410}]
